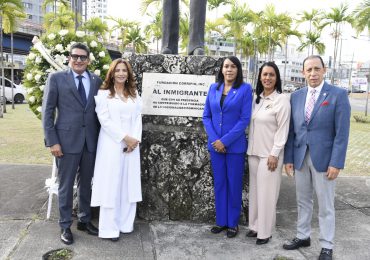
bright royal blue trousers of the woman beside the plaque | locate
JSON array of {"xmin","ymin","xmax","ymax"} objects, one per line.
[{"xmin": 210, "ymin": 152, "xmax": 245, "ymax": 228}]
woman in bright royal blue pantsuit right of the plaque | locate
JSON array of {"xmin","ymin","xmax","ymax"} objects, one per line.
[{"xmin": 203, "ymin": 56, "xmax": 253, "ymax": 238}]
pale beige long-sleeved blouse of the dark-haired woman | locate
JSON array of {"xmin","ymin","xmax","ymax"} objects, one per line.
[{"xmin": 247, "ymin": 91, "xmax": 291, "ymax": 157}]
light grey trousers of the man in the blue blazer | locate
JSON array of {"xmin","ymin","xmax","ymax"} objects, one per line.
[{"xmin": 295, "ymin": 151, "xmax": 336, "ymax": 249}]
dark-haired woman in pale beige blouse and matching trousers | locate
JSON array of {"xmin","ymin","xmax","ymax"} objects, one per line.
[{"xmin": 247, "ymin": 62, "xmax": 290, "ymax": 245}]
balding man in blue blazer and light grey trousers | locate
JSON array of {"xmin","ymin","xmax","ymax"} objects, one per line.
[{"xmin": 283, "ymin": 55, "xmax": 351, "ymax": 260}]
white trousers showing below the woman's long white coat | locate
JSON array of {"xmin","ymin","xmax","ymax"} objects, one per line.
[{"xmin": 99, "ymin": 157, "xmax": 136, "ymax": 238}]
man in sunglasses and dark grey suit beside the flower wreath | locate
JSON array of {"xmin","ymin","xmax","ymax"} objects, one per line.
[{"xmin": 42, "ymin": 43, "xmax": 102, "ymax": 245}]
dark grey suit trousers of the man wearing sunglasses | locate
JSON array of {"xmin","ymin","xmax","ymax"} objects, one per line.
[{"xmin": 57, "ymin": 144, "xmax": 95, "ymax": 228}]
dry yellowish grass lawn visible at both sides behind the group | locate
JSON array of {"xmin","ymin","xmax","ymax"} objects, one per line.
[{"xmin": 0, "ymin": 104, "xmax": 370, "ymax": 176}]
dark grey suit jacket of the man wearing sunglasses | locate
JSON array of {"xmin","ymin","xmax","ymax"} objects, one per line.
[{"xmin": 42, "ymin": 69, "xmax": 102, "ymax": 153}]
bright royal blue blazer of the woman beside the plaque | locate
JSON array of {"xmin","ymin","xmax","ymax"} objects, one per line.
[{"xmin": 203, "ymin": 83, "xmax": 253, "ymax": 153}]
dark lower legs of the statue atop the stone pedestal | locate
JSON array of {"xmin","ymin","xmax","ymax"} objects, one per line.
[{"xmin": 162, "ymin": 0, "xmax": 207, "ymax": 55}]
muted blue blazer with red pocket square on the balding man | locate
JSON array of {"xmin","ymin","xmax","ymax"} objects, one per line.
[{"xmin": 284, "ymin": 83, "xmax": 351, "ymax": 172}]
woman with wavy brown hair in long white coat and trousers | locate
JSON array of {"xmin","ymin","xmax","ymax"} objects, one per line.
[{"xmin": 91, "ymin": 59, "xmax": 142, "ymax": 241}]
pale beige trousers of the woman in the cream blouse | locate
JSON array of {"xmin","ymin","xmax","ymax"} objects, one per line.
[{"xmin": 248, "ymin": 155, "xmax": 283, "ymax": 239}]
